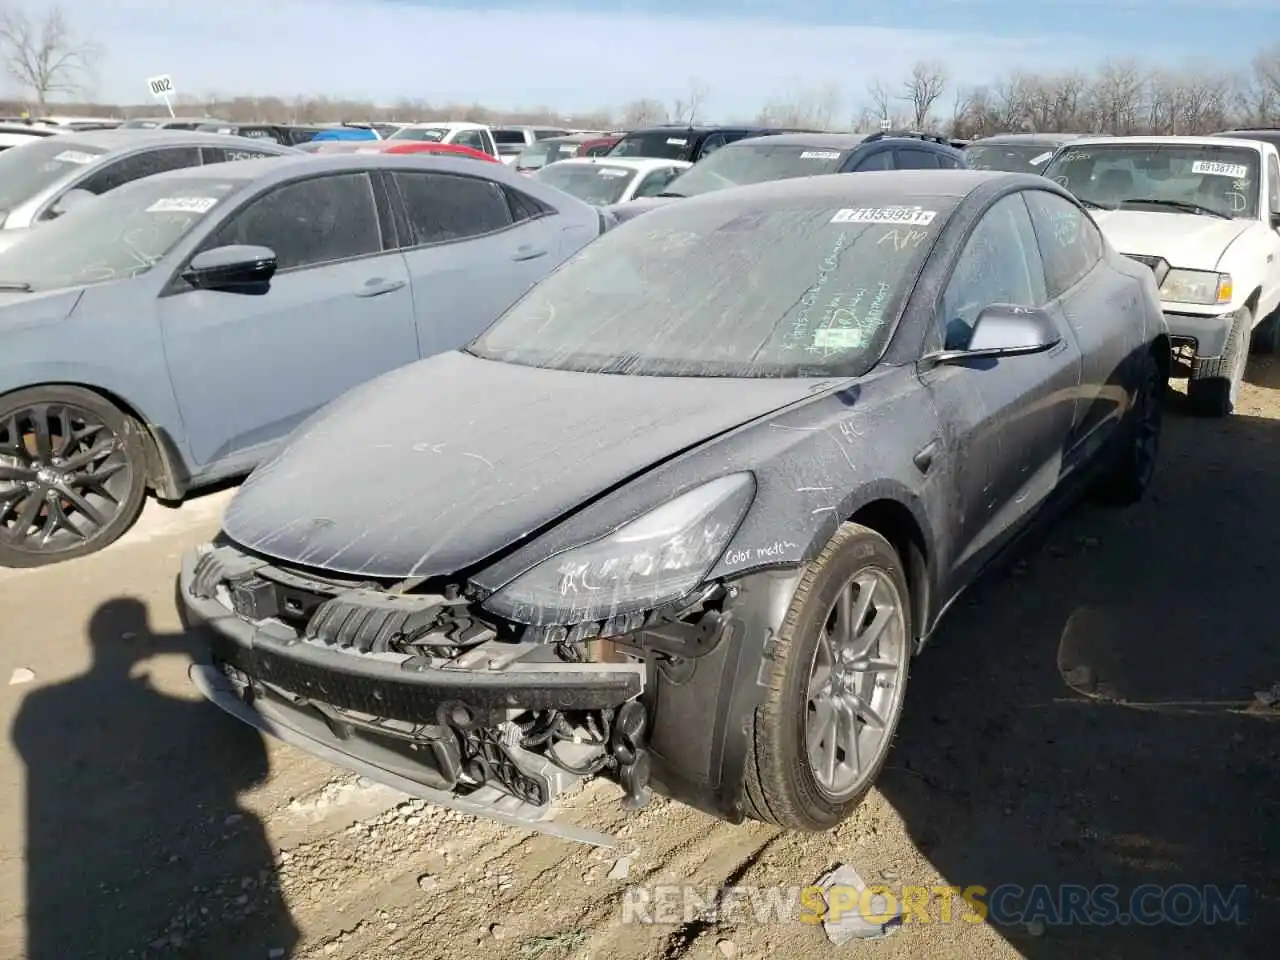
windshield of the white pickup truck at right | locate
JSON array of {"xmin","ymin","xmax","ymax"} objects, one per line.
[{"xmin": 1044, "ymin": 142, "xmax": 1261, "ymax": 219}]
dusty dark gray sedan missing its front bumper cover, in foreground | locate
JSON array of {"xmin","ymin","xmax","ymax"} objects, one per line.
[{"xmin": 178, "ymin": 170, "xmax": 1170, "ymax": 842}]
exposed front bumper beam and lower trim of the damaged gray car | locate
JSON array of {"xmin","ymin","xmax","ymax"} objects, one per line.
[{"xmin": 177, "ymin": 548, "xmax": 645, "ymax": 845}]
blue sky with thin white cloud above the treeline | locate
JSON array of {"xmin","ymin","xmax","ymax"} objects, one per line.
[{"xmin": 27, "ymin": 0, "xmax": 1280, "ymax": 116}]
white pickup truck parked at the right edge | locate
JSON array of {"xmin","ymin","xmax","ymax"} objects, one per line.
[{"xmin": 1044, "ymin": 137, "xmax": 1280, "ymax": 416}]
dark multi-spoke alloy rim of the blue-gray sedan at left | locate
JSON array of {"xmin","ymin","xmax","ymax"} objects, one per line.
[{"xmin": 0, "ymin": 403, "xmax": 136, "ymax": 554}]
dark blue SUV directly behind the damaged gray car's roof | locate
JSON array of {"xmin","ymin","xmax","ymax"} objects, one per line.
[{"xmin": 611, "ymin": 131, "xmax": 965, "ymax": 220}]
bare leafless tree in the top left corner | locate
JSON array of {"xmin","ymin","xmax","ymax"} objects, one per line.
[{"xmin": 0, "ymin": 5, "xmax": 100, "ymax": 113}]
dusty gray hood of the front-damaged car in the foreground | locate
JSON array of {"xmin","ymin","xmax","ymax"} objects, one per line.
[{"xmin": 223, "ymin": 352, "xmax": 831, "ymax": 579}]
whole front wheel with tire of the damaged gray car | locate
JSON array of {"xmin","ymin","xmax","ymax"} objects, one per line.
[{"xmin": 746, "ymin": 524, "xmax": 913, "ymax": 831}]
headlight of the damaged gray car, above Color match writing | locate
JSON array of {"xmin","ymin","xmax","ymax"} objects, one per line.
[{"xmin": 484, "ymin": 474, "xmax": 755, "ymax": 626}]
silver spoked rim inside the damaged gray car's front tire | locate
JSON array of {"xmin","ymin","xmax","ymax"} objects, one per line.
[{"xmin": 805, "ymin": 567, "xmax": 910, "ymax": 803}]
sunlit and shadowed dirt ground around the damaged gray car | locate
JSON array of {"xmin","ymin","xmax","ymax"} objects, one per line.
[{"xmin": 0, "ymin": 361, "xmax": 1280, "ymax": 960}]
